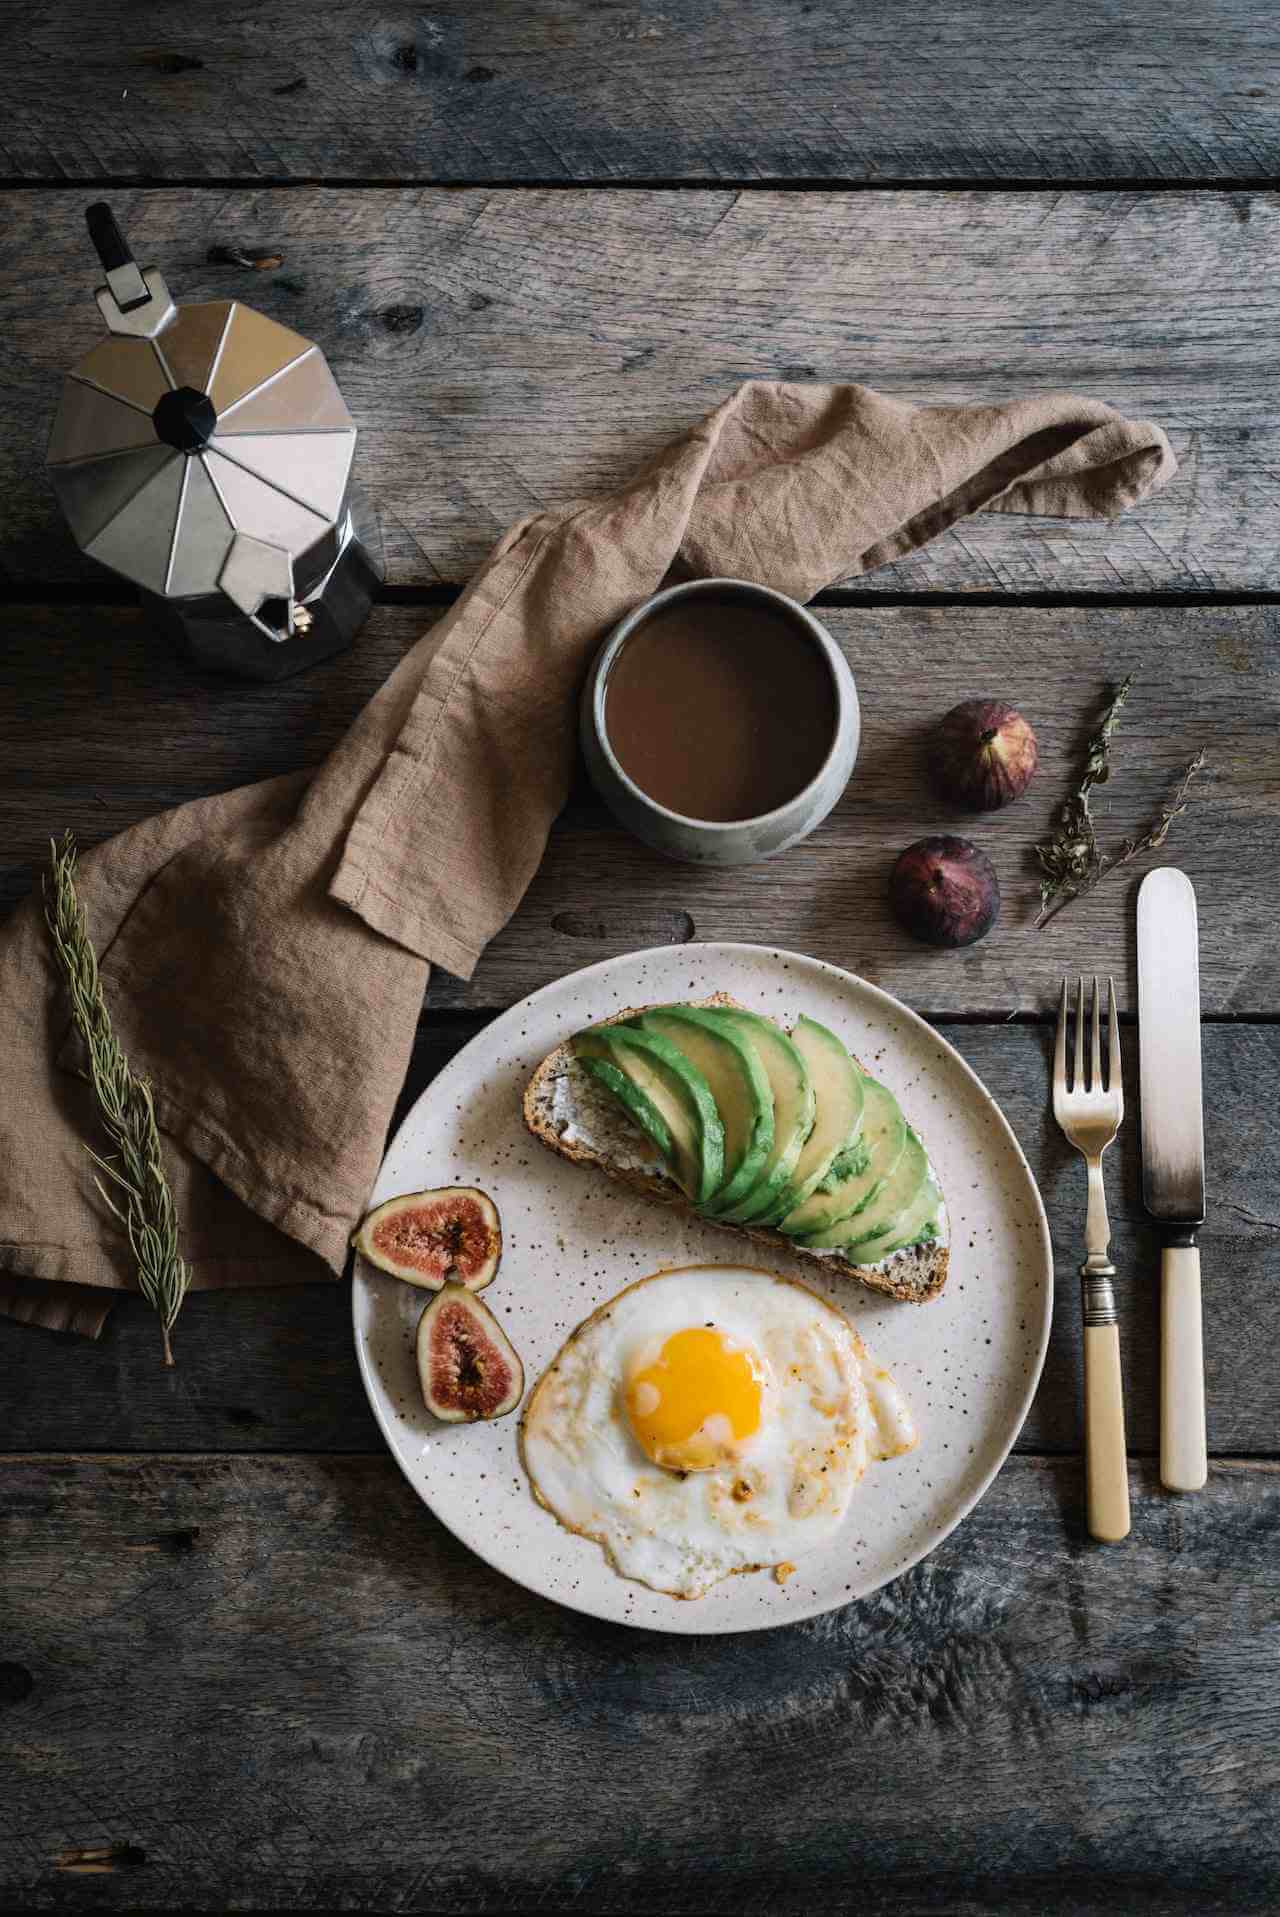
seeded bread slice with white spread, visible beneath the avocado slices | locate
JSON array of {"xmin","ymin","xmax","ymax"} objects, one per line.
[{"xmin": 525, "ymin": 991, "xmax": 950, "ymax": 1304}]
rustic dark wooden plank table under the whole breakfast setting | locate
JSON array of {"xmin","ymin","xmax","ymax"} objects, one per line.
[{"xmin": 0, "ymin": 0, "xmax": 1280, "ymax": 1913}]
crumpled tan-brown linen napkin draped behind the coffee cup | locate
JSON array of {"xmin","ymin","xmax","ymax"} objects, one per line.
[{"xmin": 0, "ymin": 383, "xmax": 1175, "ymax": 1336}]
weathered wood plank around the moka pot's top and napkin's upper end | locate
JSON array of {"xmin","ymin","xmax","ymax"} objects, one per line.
[{"xmin": 0, "ymin": 188, "xmax": 1280, "ymax": 592}]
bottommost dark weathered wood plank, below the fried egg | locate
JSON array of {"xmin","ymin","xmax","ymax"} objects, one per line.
[{"xmin": 0, "ymin": 1457, "xmax": 1280, "ymax": 1917}]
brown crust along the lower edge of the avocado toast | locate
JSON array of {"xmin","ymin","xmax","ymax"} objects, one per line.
[{"xmin": 523, "ymin": 991, "xmax": 950, "ymax": 1304}]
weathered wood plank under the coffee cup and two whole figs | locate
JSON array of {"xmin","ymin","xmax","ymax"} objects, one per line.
[{"xmin": 0, "ymin": 608, "xmax": 1280, "ymax": 1016}]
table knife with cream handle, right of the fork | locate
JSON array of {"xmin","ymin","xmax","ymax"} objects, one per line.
[{"xmin": 1138, "ymin": 866, "xmax": 1209, "ymax": 1491}]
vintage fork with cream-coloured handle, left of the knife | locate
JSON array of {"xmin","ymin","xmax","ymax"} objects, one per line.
[{"xmin": 1054, "ymin": 976, "xmax": 1129, "ymax": 1543}]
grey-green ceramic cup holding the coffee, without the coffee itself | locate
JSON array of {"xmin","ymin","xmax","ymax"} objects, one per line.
[{"xmin": 581, "ymin": 579, "xmax": 860, "ymax": 865}]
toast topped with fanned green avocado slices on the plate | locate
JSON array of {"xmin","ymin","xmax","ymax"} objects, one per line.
[{"xmin": 525, "ymin": 993, "xmax": 949, "ymax": 1304}]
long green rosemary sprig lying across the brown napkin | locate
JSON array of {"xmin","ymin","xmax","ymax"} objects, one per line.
[{"xmin": 44, "ymin": 832, "xmax": 190, "ymax": 1365}]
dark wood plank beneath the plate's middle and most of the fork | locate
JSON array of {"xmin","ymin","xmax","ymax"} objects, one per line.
[{"xmin": 0, "ymin": 1018, "xmax": 1280, "ymax": 1455}]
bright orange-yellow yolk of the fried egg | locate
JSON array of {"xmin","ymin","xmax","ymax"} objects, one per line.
[{"xmin": 627, "ymin": 1325, "xmax": 763, "ymax": 1470}]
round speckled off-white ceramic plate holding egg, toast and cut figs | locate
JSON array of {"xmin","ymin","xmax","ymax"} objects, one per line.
[{"xmin": 353, "ymin": 945, "xmax": 1052, "ymax": 1633}]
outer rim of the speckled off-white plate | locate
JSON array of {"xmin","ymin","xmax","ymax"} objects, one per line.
[{"xmin": 351, "ymin": 939, "xmax": 1054, "ymax": 1637}]
